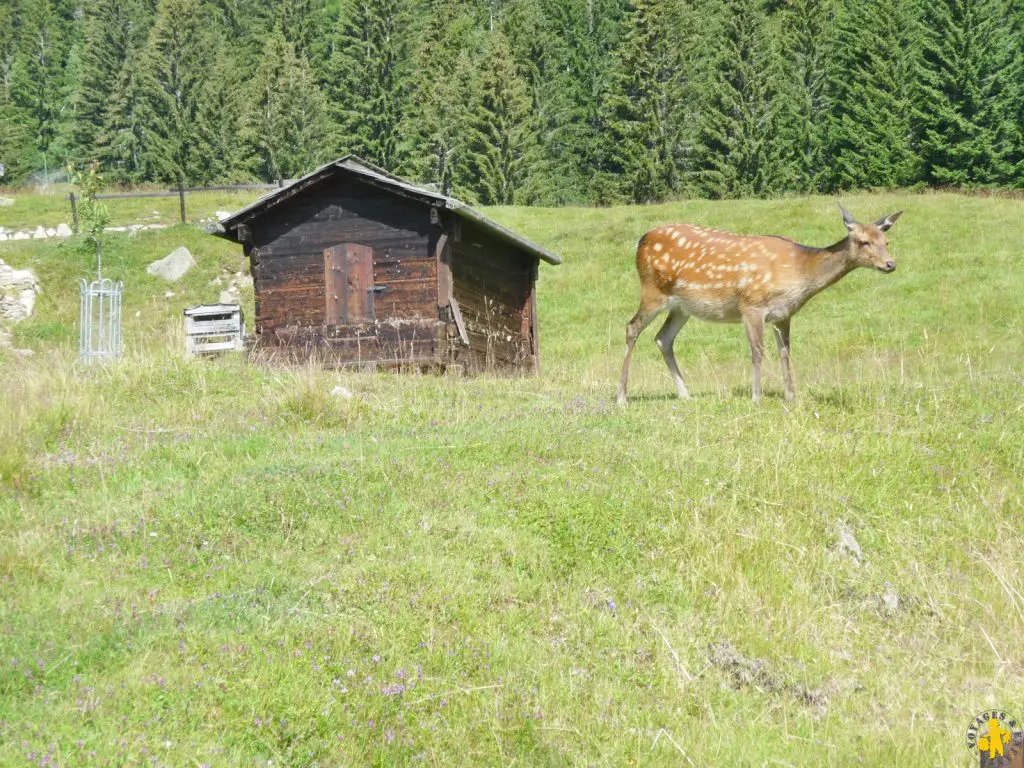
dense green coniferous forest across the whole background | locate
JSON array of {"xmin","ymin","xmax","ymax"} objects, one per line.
[{"xmin": 0, "ymin": 0, "xmax": 1024, "ymax": 205}]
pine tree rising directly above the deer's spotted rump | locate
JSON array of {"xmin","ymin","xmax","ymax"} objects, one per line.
[{"xmin": 603, "ymin": 0, "xmax": 689, "ymax": 203}]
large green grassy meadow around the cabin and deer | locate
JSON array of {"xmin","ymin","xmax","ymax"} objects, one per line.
[{"xmin": 0, "ymin": 196, "xmax": 1024, "ymax": 766}]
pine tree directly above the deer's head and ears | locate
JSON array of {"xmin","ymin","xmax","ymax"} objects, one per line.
[{"xmin": 828, "ymin": 0, "xmax": 921, "ymax": 189}]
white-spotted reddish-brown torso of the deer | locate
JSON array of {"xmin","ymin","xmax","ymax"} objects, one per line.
[{"xmin": 637, "ymin": 224, "xmax": 799, "ymax": 323}]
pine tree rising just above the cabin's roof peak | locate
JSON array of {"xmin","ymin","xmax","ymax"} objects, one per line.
[{"xmin": 326, "ymin": 0, "xmax": 407, "ymax": 169}]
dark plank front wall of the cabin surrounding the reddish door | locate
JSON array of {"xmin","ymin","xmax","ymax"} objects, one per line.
[{"xmin": 251, "ymin": 177, "xmax": 439, "ymax": 343}]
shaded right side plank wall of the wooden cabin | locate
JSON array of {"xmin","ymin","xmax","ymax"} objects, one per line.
[{"xmin": 450, "ymin": 220, "xmax": 537, "ymax": 371}]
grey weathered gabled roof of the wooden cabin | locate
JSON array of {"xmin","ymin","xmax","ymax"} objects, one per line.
[{"xmin": 211, "ymin": 155, "xmax": 562, "ymax": 264}]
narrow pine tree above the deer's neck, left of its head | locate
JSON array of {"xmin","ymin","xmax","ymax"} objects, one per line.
[{"xmin": 778, "ymin": 0, "xmax": 836, "ymax": 193}]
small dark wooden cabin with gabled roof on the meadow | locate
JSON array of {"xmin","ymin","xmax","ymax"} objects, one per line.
[{"xmin": 212, "ymin": 156, "xmax": 561, "ymax": 373}]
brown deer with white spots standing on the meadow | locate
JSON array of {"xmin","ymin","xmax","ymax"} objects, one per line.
[{"xmin": 616, "ymin": 205, "xmax": 903, "ymax": 406}]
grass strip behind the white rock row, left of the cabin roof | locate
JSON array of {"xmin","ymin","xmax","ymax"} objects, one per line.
[{"xmin": 0, "ymin": 184, "xmax": 264, "ymax": 231}]
